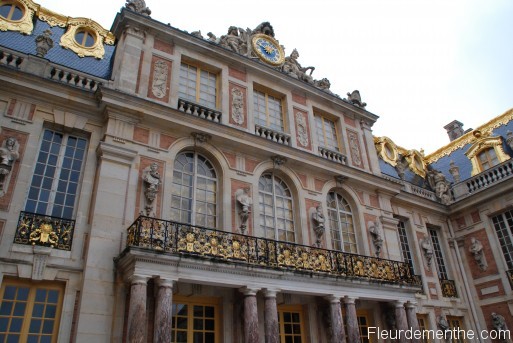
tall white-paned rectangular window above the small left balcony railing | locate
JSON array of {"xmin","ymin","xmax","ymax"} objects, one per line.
[{"xmin": 25, "ymin": 129, "xmax": 87, "ymax": 219}]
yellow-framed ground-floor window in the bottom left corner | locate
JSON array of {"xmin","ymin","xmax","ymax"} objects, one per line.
[{"xmin": 0, "ymin": 280, "xmax": 63, "ymax": 343}]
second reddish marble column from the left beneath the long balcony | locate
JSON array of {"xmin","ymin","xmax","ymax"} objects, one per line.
[{"xmin": 153, "ymin": 279, "xmax": 173, "ymax": 343}]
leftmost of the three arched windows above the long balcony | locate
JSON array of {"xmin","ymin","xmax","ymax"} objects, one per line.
[{"xmin": 171, "ymin": 151, "xmax": 217, "ymax": 227}]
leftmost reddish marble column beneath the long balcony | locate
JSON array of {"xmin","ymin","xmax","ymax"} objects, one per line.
[{"xmin": 128, "ymin": 275, "xmax": 148, "ymax": 343}]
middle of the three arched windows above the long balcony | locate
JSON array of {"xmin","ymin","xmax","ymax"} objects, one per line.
[{"xmin": 258, "ymin": 173, "xmax": 296, "ymax": 242}]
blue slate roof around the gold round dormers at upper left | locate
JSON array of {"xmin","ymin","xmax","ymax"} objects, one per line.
[{"xmin": 0, "ymin": 19, "xmax": 116, "ymax": 79}]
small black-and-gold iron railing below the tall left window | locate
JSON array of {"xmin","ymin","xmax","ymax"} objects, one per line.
[{"xmin": 14, "ymin": 211, "xmax": 75, "ymax": 251}]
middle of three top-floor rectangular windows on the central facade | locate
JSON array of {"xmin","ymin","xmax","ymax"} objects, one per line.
[{"xmin": 253, "ymin": 90, "xmax": 284, "ymax": 132}]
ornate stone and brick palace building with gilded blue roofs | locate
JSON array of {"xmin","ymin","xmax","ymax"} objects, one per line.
[{"xmin": 0, "ymin": 0, "xmax": 513, "ymax": 343}]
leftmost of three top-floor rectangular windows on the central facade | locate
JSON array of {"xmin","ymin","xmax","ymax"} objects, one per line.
[{"xmin": 178, "ymin": 62, "xmax": 217, "ymax": 109}]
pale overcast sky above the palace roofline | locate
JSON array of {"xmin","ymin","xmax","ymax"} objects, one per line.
[{"xmin": 35, "ymin": 0, "xmax": 513, "ymax": 154}]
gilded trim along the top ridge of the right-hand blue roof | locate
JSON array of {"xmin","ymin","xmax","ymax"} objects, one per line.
[{"xmin": 426, "ymin": 109, "xmax": 513, "ymax": 164}]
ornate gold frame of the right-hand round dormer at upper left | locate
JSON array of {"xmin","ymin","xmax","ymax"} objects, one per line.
[{"xmin": 60, "ymin": 18, "xmax": 115, "ymax": 59}]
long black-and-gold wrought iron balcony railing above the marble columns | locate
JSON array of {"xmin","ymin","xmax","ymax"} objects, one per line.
[{"xmin": 127, "ymin": 216, "xmax": 422, "ymax": 287}]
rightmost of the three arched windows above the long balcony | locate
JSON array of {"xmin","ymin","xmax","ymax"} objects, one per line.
[{"xmin": 326, "ymin": 192, "xmax": 357, "ymax": 253}]
